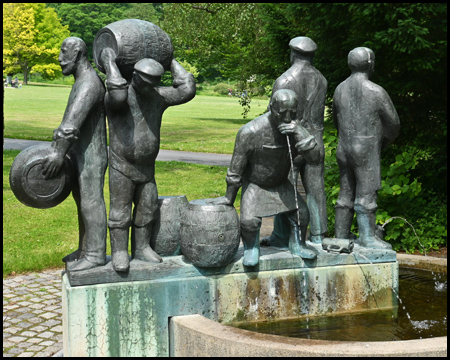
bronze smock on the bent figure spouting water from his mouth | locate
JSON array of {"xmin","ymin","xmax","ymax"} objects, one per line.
[{"xmin": 227, "ymin": 114, "xmax": 310, "ymax": 217}]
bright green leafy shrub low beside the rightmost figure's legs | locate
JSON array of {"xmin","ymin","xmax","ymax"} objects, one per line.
[{"xmin": 324, "ymin": 130, "xmax": 447, "ymax": 252}]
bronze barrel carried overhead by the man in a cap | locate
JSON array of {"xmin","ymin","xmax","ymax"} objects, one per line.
[{"xmin": 93, "ymin": 19, "xmax": 173, "ymax": 79}]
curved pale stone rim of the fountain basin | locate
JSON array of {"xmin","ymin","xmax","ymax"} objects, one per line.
[{"xmin": 170, "ymin": 254, "xmax": 447, "ymax": 357}]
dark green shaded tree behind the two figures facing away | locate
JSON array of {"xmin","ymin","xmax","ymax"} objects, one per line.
[{"xmin": 259, "ymin": 3, "xmax": 447, "ymax": 195}]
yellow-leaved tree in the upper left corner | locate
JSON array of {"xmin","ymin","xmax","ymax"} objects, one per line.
[{"xmin": 3, "ymin": 3, "xmax": 69, "ymax": 84}]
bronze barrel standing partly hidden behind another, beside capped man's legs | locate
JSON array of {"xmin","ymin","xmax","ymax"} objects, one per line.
[{"xmin": 150, "ymin": 195, "xmax": 188, "ymax": 256}]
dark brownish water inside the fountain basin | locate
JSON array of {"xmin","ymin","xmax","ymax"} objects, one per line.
[{"xmin": 238, "ymin": 268, "xmax": 447, "ymax": 341}]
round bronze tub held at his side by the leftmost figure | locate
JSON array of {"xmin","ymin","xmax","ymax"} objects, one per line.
[{"xmin": 9, "ymin": 143, "xmax": 75, "ymax": 209}]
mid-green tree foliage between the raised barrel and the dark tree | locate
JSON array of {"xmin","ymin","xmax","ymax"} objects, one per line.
[{"xmin": 161, "ymin": 3, "xmax": 265, "ymax": 81}]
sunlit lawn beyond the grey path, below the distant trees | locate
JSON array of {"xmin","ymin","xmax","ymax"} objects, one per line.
[{"xmin": 4, "ymin": 85, "xmax": 268, "ymax": 154}]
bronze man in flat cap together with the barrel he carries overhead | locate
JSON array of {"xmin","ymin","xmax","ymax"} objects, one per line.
[{"xmin": 94, "ymin": 20, "xmax": 195, "ymax": 272}]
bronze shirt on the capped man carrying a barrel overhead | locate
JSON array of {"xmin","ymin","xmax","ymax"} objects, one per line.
[{"xmin": 106, "ymin": 73, "xmax": 195, "ymax": 183}]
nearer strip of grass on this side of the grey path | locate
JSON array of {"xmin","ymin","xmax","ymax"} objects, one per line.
[{"xmin": 3, "ymin": 150, "xmax": 240, "ymax": 277}]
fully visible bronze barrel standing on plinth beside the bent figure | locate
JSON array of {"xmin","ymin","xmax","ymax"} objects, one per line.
[{"xmin": 180, "ymin": 199, "xmax": 240, "ymax": 267}]
